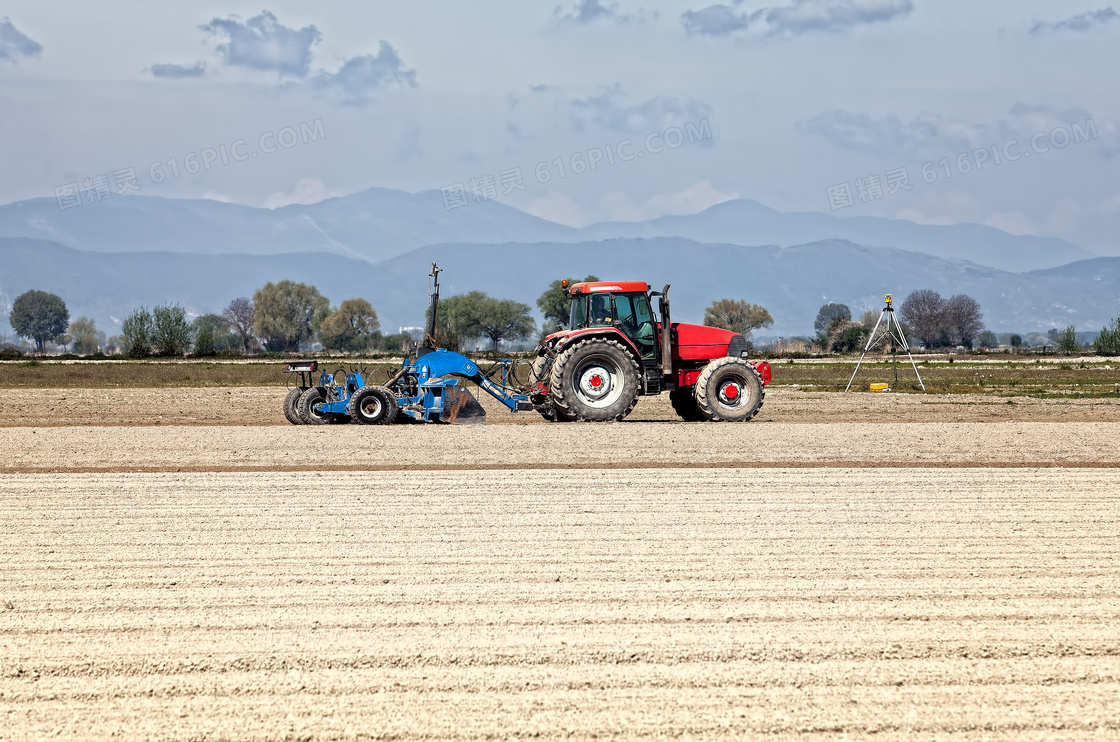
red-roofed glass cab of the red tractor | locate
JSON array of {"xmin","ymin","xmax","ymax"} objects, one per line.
[{"xmin": 568, "ymin": 281, "xmax": 657, "ymax": 361}]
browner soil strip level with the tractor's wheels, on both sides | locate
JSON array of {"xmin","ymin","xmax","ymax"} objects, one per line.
[{"xmin": 0, "ymin": 387, "xmax": 1120, "ymax": 427}]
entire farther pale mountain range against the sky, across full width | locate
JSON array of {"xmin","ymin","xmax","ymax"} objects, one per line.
[{"xmin": 0, "ymin": 188, "xmax": 1096, "ymax": 272}]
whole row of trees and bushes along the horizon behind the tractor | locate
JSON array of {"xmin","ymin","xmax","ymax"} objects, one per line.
[{"xmin": 9, "ymin": 282, "xmax": 1120, "ymax": 358}]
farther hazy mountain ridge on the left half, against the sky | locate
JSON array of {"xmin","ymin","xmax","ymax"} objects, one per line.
[{"xmin": 0, "ymin": 188, "xmax": 576, "ymax": 262}]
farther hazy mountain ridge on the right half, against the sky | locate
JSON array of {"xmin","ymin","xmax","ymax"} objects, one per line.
[{"xmin": 580, "ymin": 200, "xmax": 1096, "ymax": 271}]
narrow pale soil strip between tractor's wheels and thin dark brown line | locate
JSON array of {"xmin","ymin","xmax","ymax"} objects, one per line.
[{"xmin": 0, "ymin": 423, "xmax": 1120, "ymax": 473}]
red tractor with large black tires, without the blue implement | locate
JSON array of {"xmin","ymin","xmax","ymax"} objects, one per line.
[{"xmin": 528, "ymin": 281, "xmax": 771, "ymax": 423}]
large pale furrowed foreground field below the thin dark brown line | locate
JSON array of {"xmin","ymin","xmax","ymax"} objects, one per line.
[{"xmin": 0, "ymin": 472, "xmax": 1120, "ymax": 740}]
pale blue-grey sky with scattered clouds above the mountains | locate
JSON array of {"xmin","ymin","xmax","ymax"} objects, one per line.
[{"xmin": 0, "ymin": 0, "xmax": 1120, "ymax": 252}]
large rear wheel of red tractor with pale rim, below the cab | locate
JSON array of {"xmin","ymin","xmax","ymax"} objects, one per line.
[{"xmin": 549, "ymin": 337, "xmax": 641, "ymax": 423}]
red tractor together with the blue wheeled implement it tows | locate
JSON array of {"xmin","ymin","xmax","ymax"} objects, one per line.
[{"xmin": 284, "ymin": 265, "xmax": 771, "ymax": 425}]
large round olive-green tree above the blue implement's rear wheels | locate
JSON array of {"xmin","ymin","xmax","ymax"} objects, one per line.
[{"xmin": 253, "ymin": 280, "xmax": 330, "ymax": 351}]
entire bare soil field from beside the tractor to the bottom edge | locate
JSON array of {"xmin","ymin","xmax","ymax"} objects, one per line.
[{"xmin": 0, "ymin": 381, "xmax": 1120, "ymax": 740}]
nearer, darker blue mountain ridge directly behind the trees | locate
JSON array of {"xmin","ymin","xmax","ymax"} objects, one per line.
[{"xmin": 0, "ymin": 238, "xmax": 1120, "ymax": 335}]
